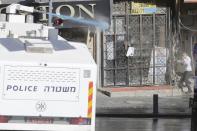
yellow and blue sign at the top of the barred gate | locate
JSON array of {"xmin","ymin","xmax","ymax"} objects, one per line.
[{"xmin": 131, "ymin": 2, "xmax": 157, "ymax": 14}]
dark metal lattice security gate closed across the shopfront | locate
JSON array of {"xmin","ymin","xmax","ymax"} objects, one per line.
[{"xmin": 102, "ymin": 4, "xmax": 169, "ymax": 87}]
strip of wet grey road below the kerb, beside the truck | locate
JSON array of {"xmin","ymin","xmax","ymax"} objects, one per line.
[{"xmin": 96, "ymin": 117, "xmax": 190, "ymax": 131}]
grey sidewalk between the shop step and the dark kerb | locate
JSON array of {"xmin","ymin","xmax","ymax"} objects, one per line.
[{"xmin": 96, "ymin": 90, "xmax": 193, "ymax": 115}]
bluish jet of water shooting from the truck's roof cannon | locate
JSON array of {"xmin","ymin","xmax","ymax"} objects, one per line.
[{"xmin": 47, "ymin": 13, "xmax": 109, "ymax": 30}]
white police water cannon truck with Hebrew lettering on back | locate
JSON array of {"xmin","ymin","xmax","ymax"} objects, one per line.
[{"xmin": 0, "ymin": 4, "xmax": 96, "ymax": 131}]
